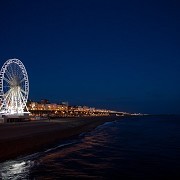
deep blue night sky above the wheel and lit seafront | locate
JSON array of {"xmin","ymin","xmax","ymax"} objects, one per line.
[{"xmin": 0, "ymin": 0, "xmax": 180, "ymax": 114}]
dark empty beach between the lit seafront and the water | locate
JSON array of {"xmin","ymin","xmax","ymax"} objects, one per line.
[{"xmin": 0, "ymin": 116, "xmax": 122, "ymax": 163}]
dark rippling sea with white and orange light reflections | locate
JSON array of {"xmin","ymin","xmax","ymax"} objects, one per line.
[{"xmin": 0, "ymin": 115, "xmax": 180, "ymax": 180}]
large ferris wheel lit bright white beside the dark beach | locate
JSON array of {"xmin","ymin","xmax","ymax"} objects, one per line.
[{"xmin": 0, "ymin": 59, "xmax": 29, "ymax": 114}]
